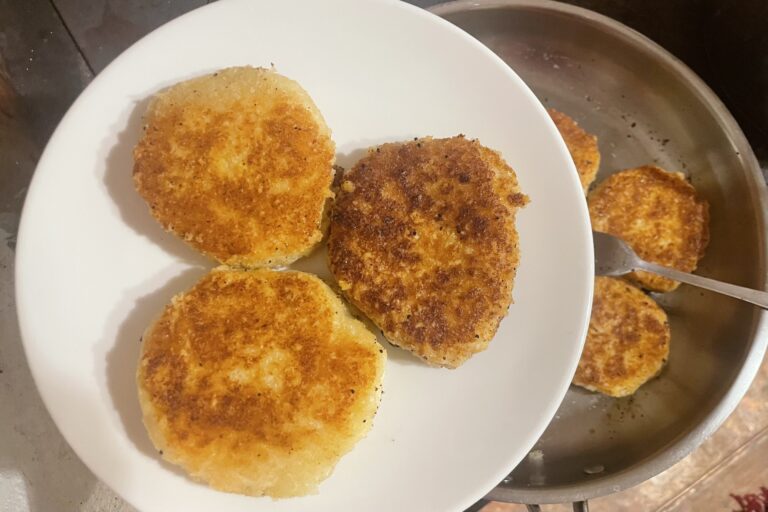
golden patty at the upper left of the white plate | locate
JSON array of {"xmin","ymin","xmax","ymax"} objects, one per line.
[{"xmin": 133, "ymin": 67, "xmax": 335, "ymax": 266}]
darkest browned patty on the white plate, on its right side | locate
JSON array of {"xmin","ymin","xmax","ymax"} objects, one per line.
[{"xmin": 328, "ymin": 136, "xmax": 527, "ymax": 367}]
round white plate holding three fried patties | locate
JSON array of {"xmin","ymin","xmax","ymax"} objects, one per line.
[{"xmin": 17, "ymin": 0, "xmax": 592, "ymax": 512}]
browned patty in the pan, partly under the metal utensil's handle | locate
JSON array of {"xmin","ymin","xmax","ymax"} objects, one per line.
[{"xmin": 588, "ymin": 165, "xmax": 709, "ymax": 292}]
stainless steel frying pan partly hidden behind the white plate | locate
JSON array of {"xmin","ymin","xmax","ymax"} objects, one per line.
[{"xmin": 432, "ymin": 0, "xmax": 768, "ymax": 510}]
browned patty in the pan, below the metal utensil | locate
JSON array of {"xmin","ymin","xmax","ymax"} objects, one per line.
[{"xmin": 573, "ymin": 277, "xmax": 670, "ymax": 397}]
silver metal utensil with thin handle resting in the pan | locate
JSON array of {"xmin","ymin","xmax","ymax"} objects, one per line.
[{"xmin": 592, "ymin": 231, "xmax": 768, "ymax": 309}]
